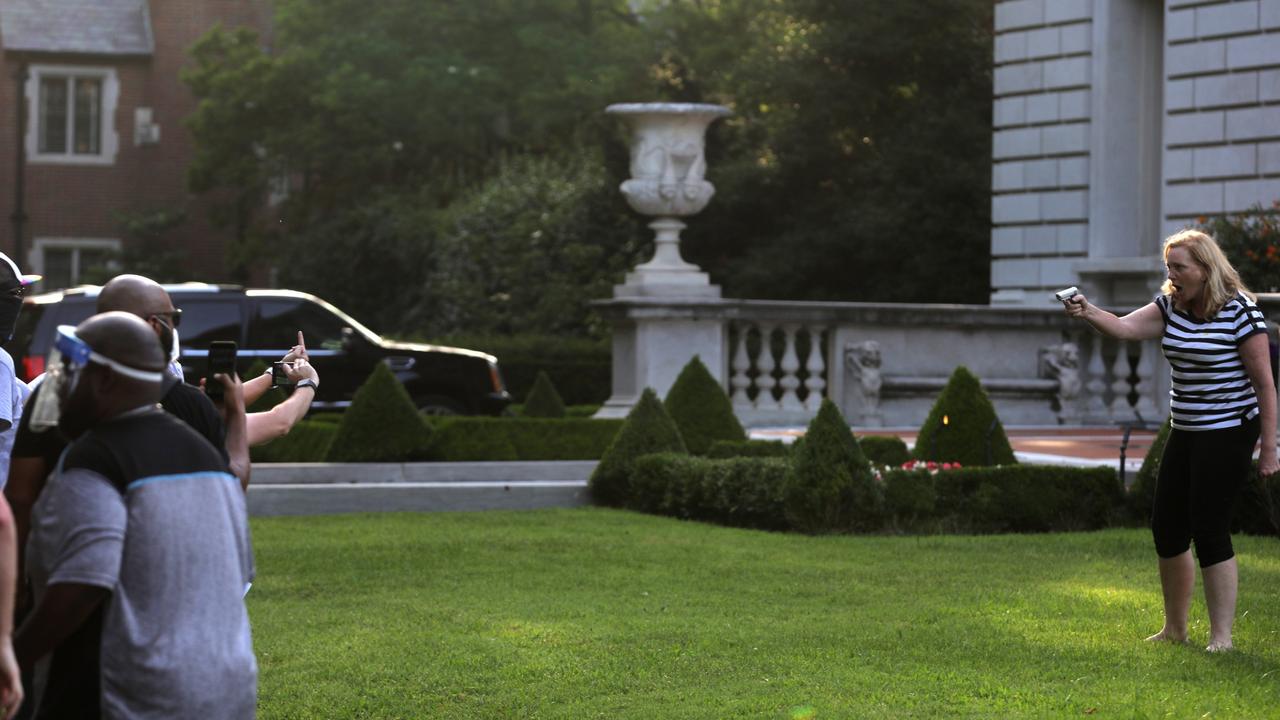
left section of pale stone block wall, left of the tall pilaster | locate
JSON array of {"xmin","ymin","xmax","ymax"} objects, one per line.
[{"xmin": 991, "ymin": 0, "xmax": 1093, "ymax": 304}]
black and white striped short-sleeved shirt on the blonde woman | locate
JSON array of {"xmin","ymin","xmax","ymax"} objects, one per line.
[{"xmin": 1156, "ymin": 293, "xmax": 1267, "ymax": 430}]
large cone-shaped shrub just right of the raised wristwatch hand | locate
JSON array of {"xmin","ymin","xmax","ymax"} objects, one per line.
[{"xmin": 325, "ymin": 363, "xmax": 431, "ymax": 462}]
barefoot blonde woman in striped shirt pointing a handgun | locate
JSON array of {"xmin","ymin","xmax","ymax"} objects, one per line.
[{"xmin": 1066, "ymin": 229, "xmax": 1280, "ymax": 651}]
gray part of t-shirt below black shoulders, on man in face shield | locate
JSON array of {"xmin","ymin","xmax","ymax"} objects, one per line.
[{"xmin": 27, "ymin": 411, "xmax": 257, "ymax": 720}]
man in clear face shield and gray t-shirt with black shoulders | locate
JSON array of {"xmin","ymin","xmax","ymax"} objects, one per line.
[{"xmin": 14, "ymin": 313, "xmax": 257, "ymax": 719}]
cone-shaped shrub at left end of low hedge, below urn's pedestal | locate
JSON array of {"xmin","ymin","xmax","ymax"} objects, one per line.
[{"xmin": 588, "ymin": 388, "xmax": 689, "ymax": 507}]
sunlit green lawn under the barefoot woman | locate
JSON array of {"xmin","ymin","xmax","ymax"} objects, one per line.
[{"xmin": 248, "ymin": 509, "xmax": 1280, "ymax": 720}]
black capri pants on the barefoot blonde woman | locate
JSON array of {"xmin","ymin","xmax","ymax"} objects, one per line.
[{"xmin": 1151, "ymin": 415, "xmax": 1260, "ymax": 568}]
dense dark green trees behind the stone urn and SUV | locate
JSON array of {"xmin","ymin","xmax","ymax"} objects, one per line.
[{"xmin": 184, "ymin": 0, "xmax": 992, "ymax": 333}]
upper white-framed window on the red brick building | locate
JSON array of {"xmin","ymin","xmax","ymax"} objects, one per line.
[{"xmin": 27, "ymin": 65, "xmax": 120, "ymax": 164}]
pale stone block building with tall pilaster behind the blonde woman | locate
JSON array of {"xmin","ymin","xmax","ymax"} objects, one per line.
[{"xmin": 991, "ymin": 0, "xmax": 1280, "ymax": 307}]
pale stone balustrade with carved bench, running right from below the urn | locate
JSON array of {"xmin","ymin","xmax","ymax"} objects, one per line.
[{"xmin": 598, "ymin": 299, "xmax": 1169, "ymax": 428}]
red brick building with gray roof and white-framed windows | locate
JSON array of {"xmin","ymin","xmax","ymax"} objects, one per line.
[{"xmin": 0, "ymin": 0, "xmax": 270, "ymax": 290}]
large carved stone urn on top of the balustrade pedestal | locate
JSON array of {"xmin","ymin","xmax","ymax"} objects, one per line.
[{"xmin": 604, "ymin": 102, "xmax": 731, "ymax": 297}]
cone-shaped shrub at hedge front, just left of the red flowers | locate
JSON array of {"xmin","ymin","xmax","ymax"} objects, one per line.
[{"xmin": 783, "ymin": 400, "xmax": 882, "ymax": 533}]
